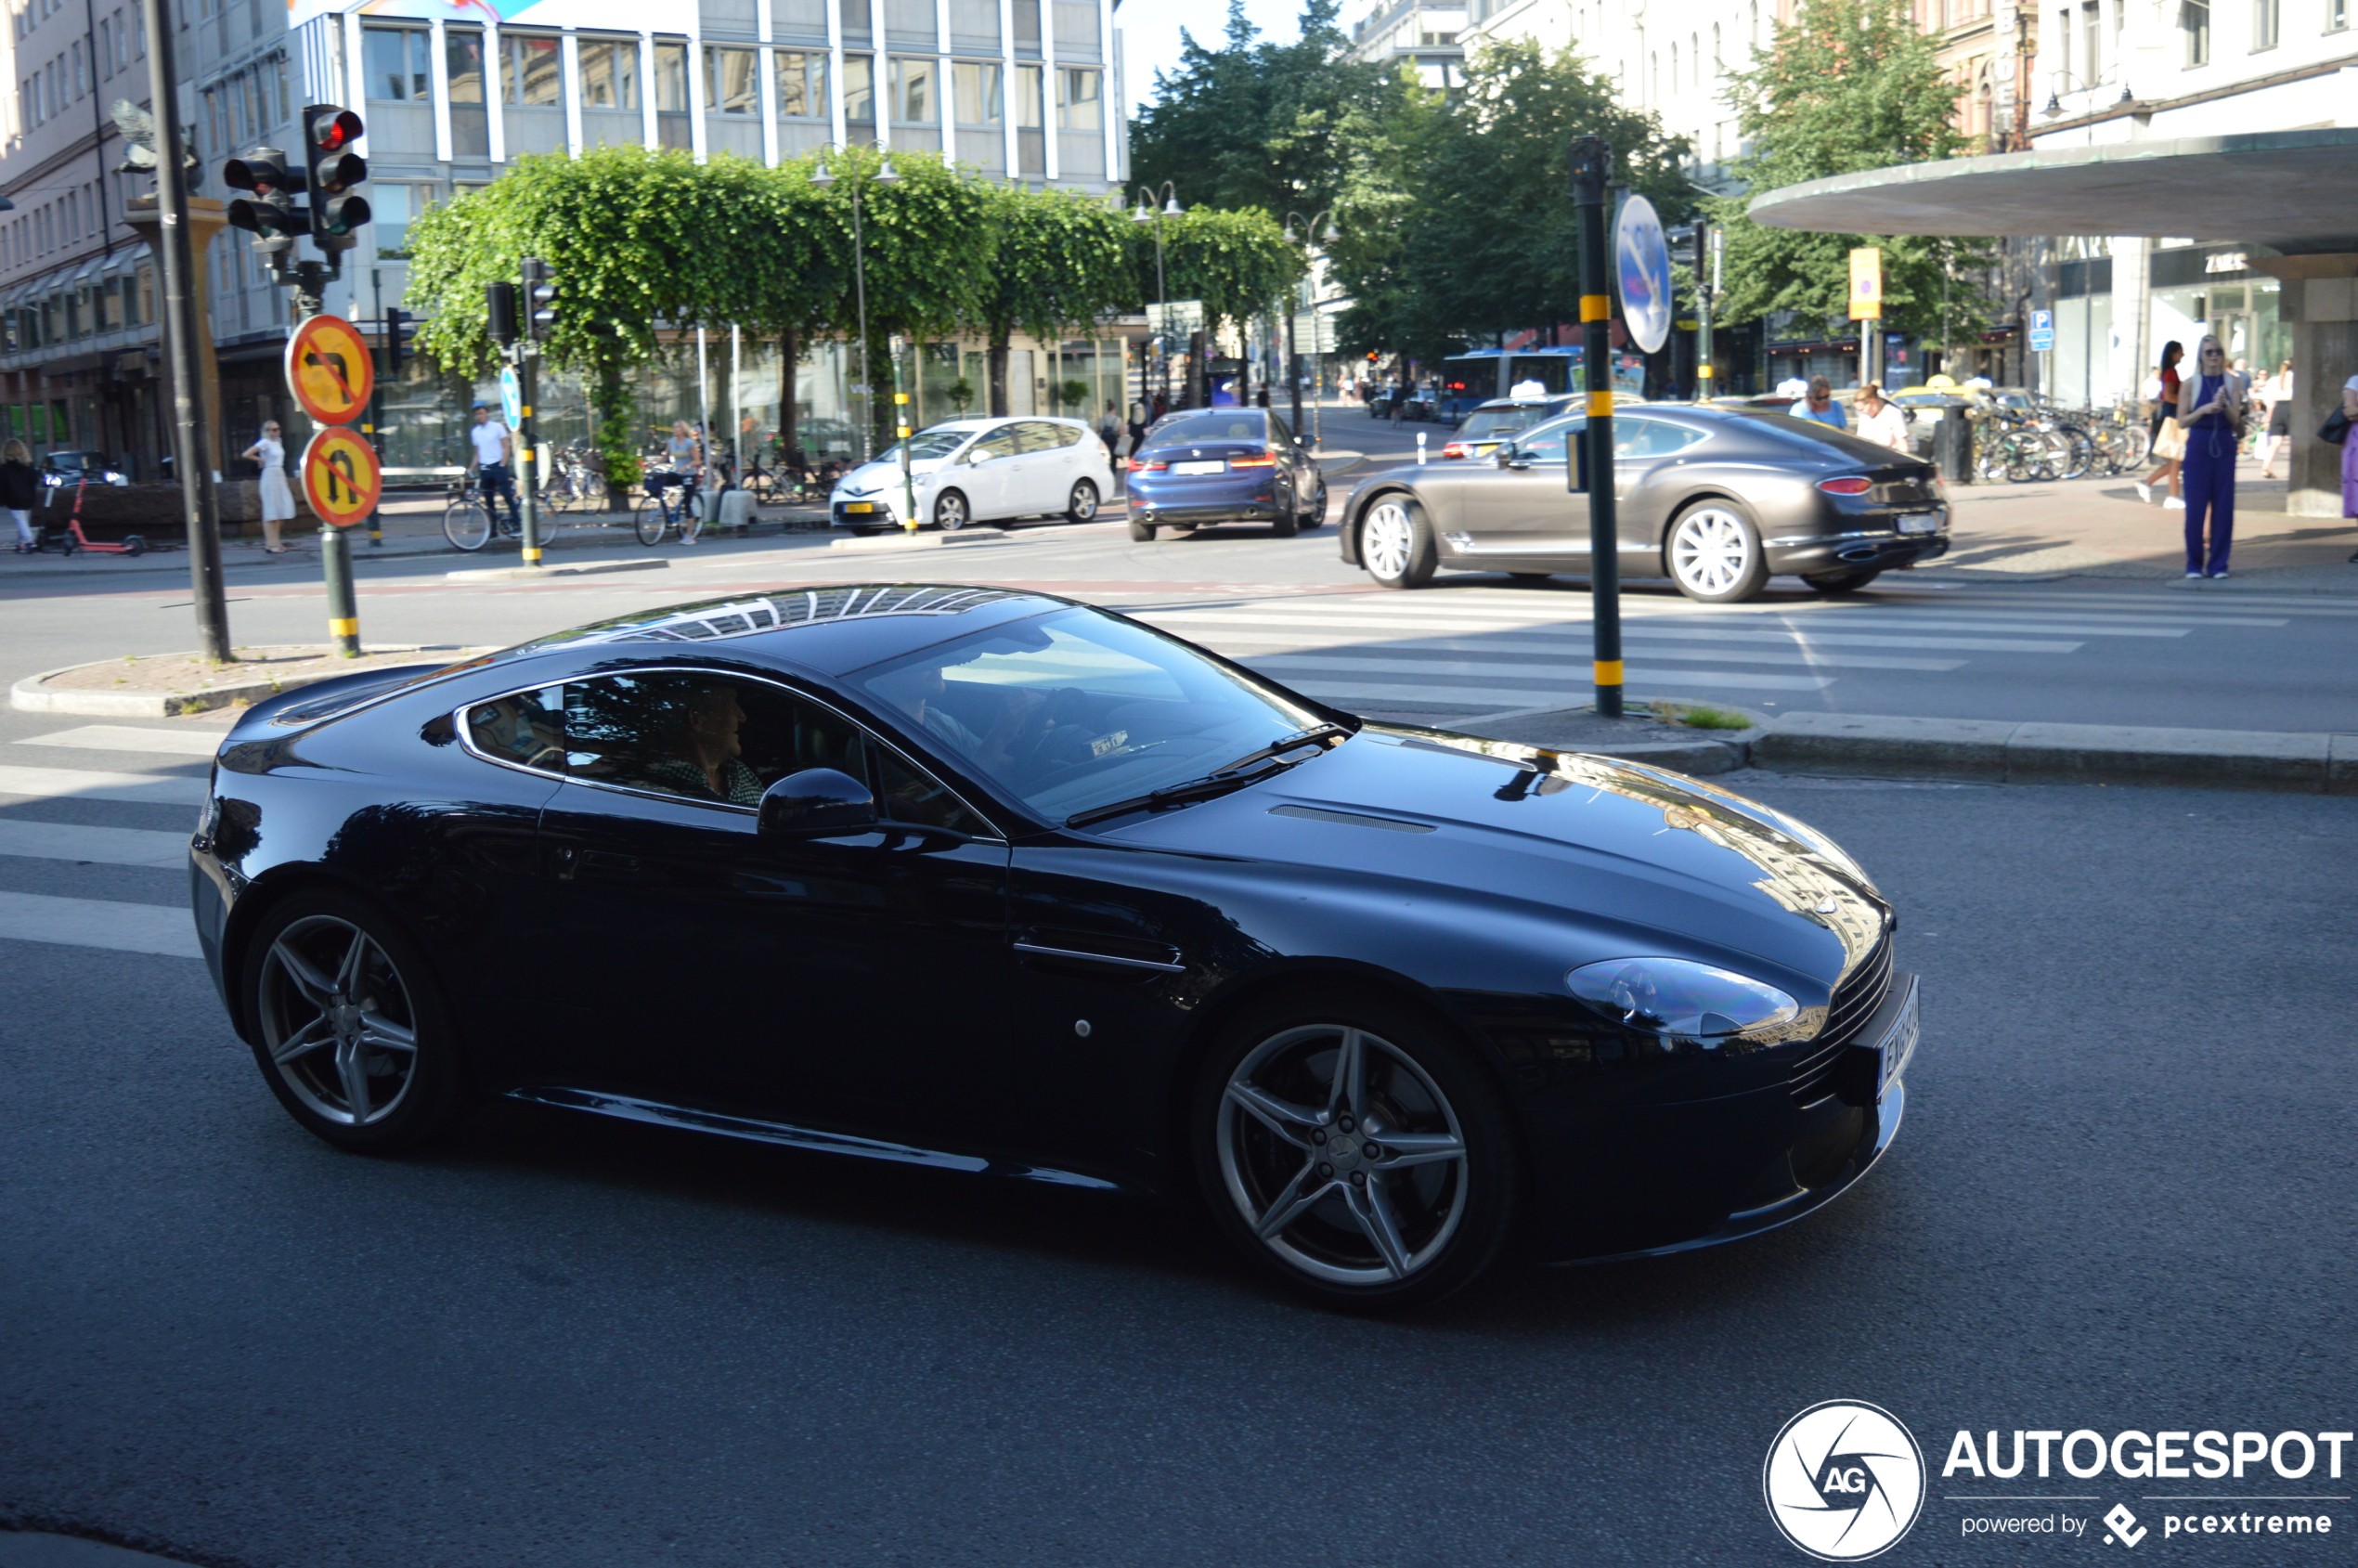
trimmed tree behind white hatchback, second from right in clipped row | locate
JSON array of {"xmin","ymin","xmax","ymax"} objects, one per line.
[{"xmin": 977, "ymin": 187, "xmax": 1139, "ymax": 415}]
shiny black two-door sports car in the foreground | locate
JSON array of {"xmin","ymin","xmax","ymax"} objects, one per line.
[{"xmin": 191, "ymin": 585, "xmax": 1917, "ymax": 1306}]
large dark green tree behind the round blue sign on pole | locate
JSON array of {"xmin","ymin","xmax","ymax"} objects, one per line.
[{"xmin": 1332, "ymin": 40, "xmax": 1693, "ymax": 361}]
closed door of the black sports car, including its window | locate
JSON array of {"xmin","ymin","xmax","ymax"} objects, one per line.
[{"xmin": 538, "ymin": 669, "xmax": 1012, "ymax": 1139}]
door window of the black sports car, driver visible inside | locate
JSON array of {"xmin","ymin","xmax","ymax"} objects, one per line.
[{"xmin": 564, "ymin": 669, "xmax": 865, "ymax": 807}]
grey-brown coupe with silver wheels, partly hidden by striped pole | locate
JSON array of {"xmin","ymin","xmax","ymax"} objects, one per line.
[{"xmin": 1341, "ymin": 403, "xmax": 1948, "ymax": 603}]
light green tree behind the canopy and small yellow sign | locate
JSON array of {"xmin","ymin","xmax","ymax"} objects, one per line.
[{"xmin": 1710, "ymin": 0, "xmax": 1992, "ymax": 344}]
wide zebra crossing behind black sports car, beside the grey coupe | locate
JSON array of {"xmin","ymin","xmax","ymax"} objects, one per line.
[{"xmin": 1121, "ymin": 582, "xmax": 2358, "ymax": 719}]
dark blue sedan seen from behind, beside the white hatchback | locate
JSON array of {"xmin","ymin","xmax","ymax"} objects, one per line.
[{"xmin": 1130, "ymin": 408, "xmax": 1328, "ymax": 540}]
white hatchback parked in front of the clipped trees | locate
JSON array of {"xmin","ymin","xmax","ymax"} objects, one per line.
[{"xmin": 828, "ymin": 418, "xmax": 1113, "ymax": 533}]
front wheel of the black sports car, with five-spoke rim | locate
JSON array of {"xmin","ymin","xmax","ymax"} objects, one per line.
[{"xmin": 1188, "ymin": 992, "xmax": 1521, "ymax": 1311}]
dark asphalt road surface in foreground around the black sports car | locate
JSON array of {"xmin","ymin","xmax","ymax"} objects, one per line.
[{"xmin": 0, "ymin": 693, "xmax": 2358, "ymax": 1568}]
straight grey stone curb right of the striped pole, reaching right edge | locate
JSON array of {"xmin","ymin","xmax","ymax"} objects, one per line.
[{"xmin": 1747, "ymin": 715, "xmax": 2358, "ymax": 795}]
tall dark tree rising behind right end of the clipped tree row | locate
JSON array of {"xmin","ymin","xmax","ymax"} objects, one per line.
[{"xmin": 1130, "ymin": 0, "xmax": 1396, "ymax": 214}]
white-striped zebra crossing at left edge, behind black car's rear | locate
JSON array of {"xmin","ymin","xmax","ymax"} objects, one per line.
[{"xmin": 0, "ymin": 724, "xmax": 219, "ymax": 960}]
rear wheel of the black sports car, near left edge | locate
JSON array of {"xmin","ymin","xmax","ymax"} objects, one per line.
[{"xmin": 239, "ymin": 891, "xmax": 464, "ymax": 1153}]
